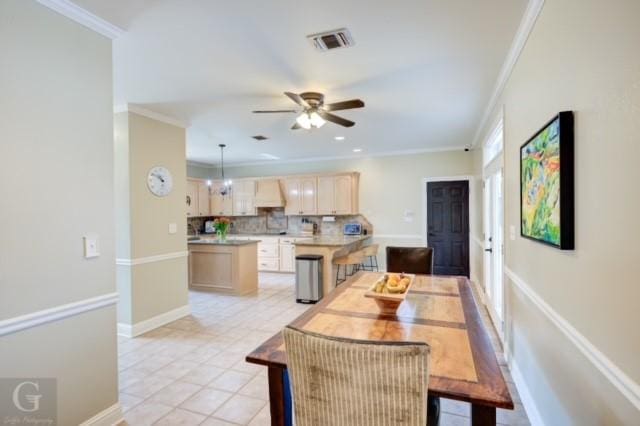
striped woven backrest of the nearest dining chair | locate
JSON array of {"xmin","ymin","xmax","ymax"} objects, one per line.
[{"xmin": 283, "ymin": 326, "xmax": 429, "ymax": 426}]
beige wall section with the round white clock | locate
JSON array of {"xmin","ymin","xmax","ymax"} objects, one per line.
[{"xmin": 115, "ymin": 112, "xmax": 188, "ymax": 325}]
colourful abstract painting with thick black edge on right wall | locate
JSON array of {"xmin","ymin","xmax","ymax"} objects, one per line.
[{"xmin": 520, "ymin": 111, "xmax": 574, "ymax": 249}]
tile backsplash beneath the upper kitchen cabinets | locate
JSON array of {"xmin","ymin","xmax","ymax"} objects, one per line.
[{"xmin": 187, "ymin": 208, "xmax": 373, "ymax": 235}]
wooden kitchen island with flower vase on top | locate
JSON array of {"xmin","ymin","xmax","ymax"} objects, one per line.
[{"xmin": 188, "ymin": 237, "xmax": 260, "ymax": 295}]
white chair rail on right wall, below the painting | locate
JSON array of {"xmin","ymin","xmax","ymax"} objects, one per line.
[{"xmin": 504, "ymin": 266, "xmax": 640, "ymax": 410}]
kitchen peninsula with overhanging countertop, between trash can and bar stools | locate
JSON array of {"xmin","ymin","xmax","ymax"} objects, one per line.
[{"xmin": 294, "ymin": 235, "xmax": 371, "ymax": 297}]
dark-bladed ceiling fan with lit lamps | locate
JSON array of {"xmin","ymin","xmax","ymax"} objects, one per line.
[{"xmin": 253, "ymin": 92, "xmax": 364, "ymax": 130}]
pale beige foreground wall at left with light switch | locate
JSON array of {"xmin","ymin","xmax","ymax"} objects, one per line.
[{"xmin": 0, "ymin": 0, "xmax": 118, "ymax": 424}]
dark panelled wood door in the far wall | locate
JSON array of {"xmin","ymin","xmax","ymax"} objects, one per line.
[{"xmin": 427, "ymin": 180, "xmax": 469, "ymax": 277}]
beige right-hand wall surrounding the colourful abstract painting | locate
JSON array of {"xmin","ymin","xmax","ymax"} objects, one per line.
[{"xmin": 478, "ymin": 0, "xmax": 640, "ymax": 425}]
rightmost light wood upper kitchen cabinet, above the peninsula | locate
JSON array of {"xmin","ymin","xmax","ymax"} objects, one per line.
[{"xmin": 318, "ymin": 173, "xmax": 359, "ymax": 215}]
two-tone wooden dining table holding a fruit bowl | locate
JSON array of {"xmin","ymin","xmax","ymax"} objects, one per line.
[{"xmin": 246, "ymin": 271, "xmax": 513, "ymax": 426}]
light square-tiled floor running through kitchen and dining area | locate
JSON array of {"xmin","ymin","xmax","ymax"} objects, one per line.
[{"xmin": 118, "ymin": 273, "xmax": 529, "ymax": 426}]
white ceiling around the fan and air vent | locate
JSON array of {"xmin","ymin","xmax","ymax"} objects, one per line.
[{"xmin": 75, "ymin": 0, "xmax": 526, "ymax": 163}]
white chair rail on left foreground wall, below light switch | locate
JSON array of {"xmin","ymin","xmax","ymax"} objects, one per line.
[{"xmin": 0, "ymin": 293, "xmax": 118, "ymax": 336}]
